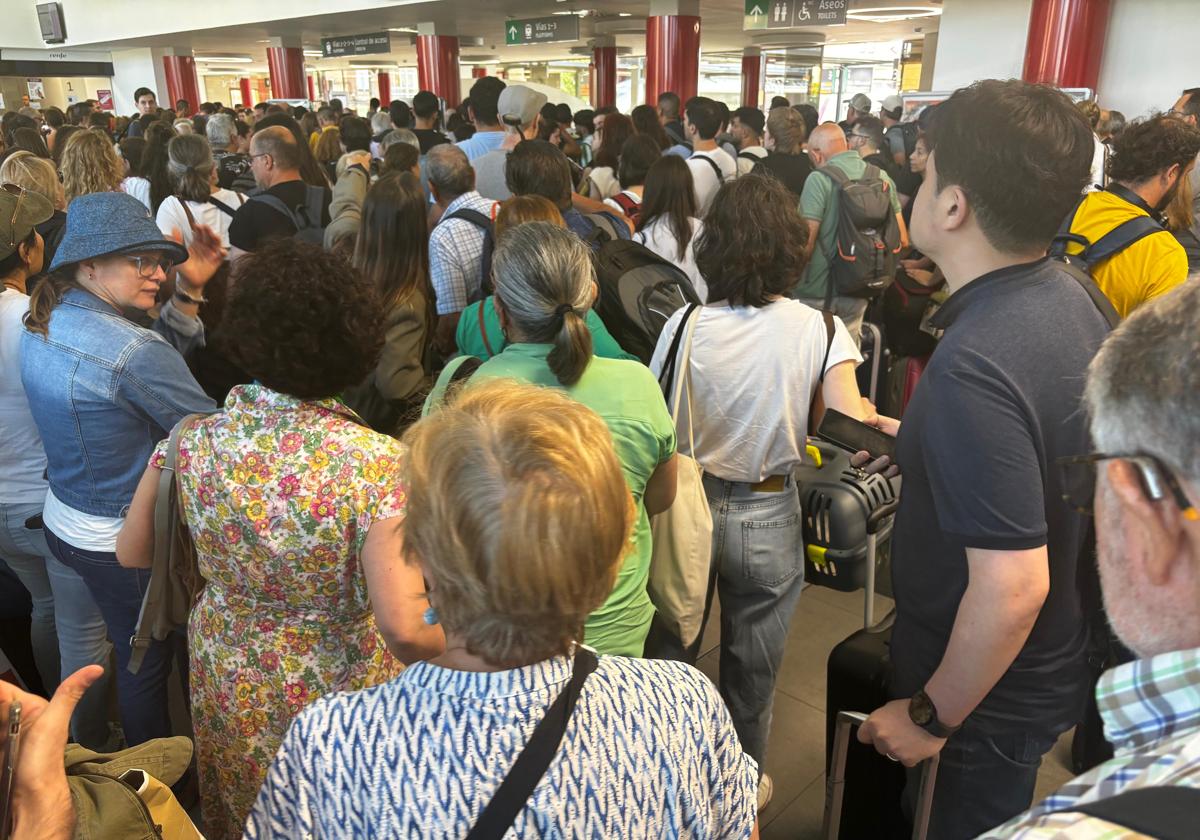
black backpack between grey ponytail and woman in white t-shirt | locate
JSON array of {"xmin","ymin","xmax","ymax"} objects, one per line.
[{"xmin": 595, "ymin": 239, "xmax": 701, "ymax": 365}]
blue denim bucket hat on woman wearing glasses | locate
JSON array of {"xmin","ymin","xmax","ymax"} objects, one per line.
[{"xmin": 50, "ymin": 192, "xmax": 187, "ymax": 271}]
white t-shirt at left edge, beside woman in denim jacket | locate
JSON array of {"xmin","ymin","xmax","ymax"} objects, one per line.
[{"xmin": 0, "ymin": 287, "xmax": 46, "ymax": 504}]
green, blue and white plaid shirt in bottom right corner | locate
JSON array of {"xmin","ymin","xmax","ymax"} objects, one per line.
[{"xmin": 983, "ymin": 648, "xmax": 1200, "ymax": 840}]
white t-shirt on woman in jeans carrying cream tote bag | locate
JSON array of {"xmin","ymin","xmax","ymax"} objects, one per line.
[{"xmin": 650, "ymin": 298, "xmax": 862, "ymax": 482}]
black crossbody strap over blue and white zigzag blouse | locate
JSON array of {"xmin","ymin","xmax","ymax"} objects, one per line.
[{"xmin": 467, "ymin": 644, "xmax": 599, "ymax": 840}]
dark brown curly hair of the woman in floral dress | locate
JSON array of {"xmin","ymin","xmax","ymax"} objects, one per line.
[{"xmin": 218, "ymin": 239, "xmax": 384, "ymax": 400}]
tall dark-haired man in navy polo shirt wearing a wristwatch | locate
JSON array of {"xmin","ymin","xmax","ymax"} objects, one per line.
[{"xmin": 859, "ymin": 80, "xmax": 1108, "ymax": 840}]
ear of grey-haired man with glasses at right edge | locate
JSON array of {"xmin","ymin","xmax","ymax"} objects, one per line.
[{"xmin": 1102, "ymin": 458, "xmax": 1196, "ymax": 587}]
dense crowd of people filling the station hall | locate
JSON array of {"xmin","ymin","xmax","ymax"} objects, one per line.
[{"xmin": 0, "ymin": 77, "xmax": 1200, "ymax": 840}]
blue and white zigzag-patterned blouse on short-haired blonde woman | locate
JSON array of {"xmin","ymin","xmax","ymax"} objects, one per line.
[{"xmin": 238, "ymin": 656, "xmax": 757, "ymax": 840}]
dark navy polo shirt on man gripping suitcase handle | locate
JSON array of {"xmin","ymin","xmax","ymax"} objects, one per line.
[{"xmin": 892, "ymin": 259, "xmax": 1108, "ymax": 736}]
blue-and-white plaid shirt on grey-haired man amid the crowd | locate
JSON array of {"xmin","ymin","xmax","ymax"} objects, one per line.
[{"xmin": 430, "ymin": 191, "xmax": 496, "ymax": 316}]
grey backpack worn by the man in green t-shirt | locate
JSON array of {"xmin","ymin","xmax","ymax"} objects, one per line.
[{"xmin": 821, "ymin": 163, "xmax": 900, "ymax": 303}]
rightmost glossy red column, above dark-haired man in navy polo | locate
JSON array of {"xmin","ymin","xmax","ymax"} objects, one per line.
[{"xmin": 1021, "ymin": 0, "xmax": 1111, "ymax": 90}]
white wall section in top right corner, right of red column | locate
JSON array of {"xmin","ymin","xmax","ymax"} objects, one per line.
[{"xmin": 1097, "ymin": 0, "xmax": 1200, "ymax": 119}]
